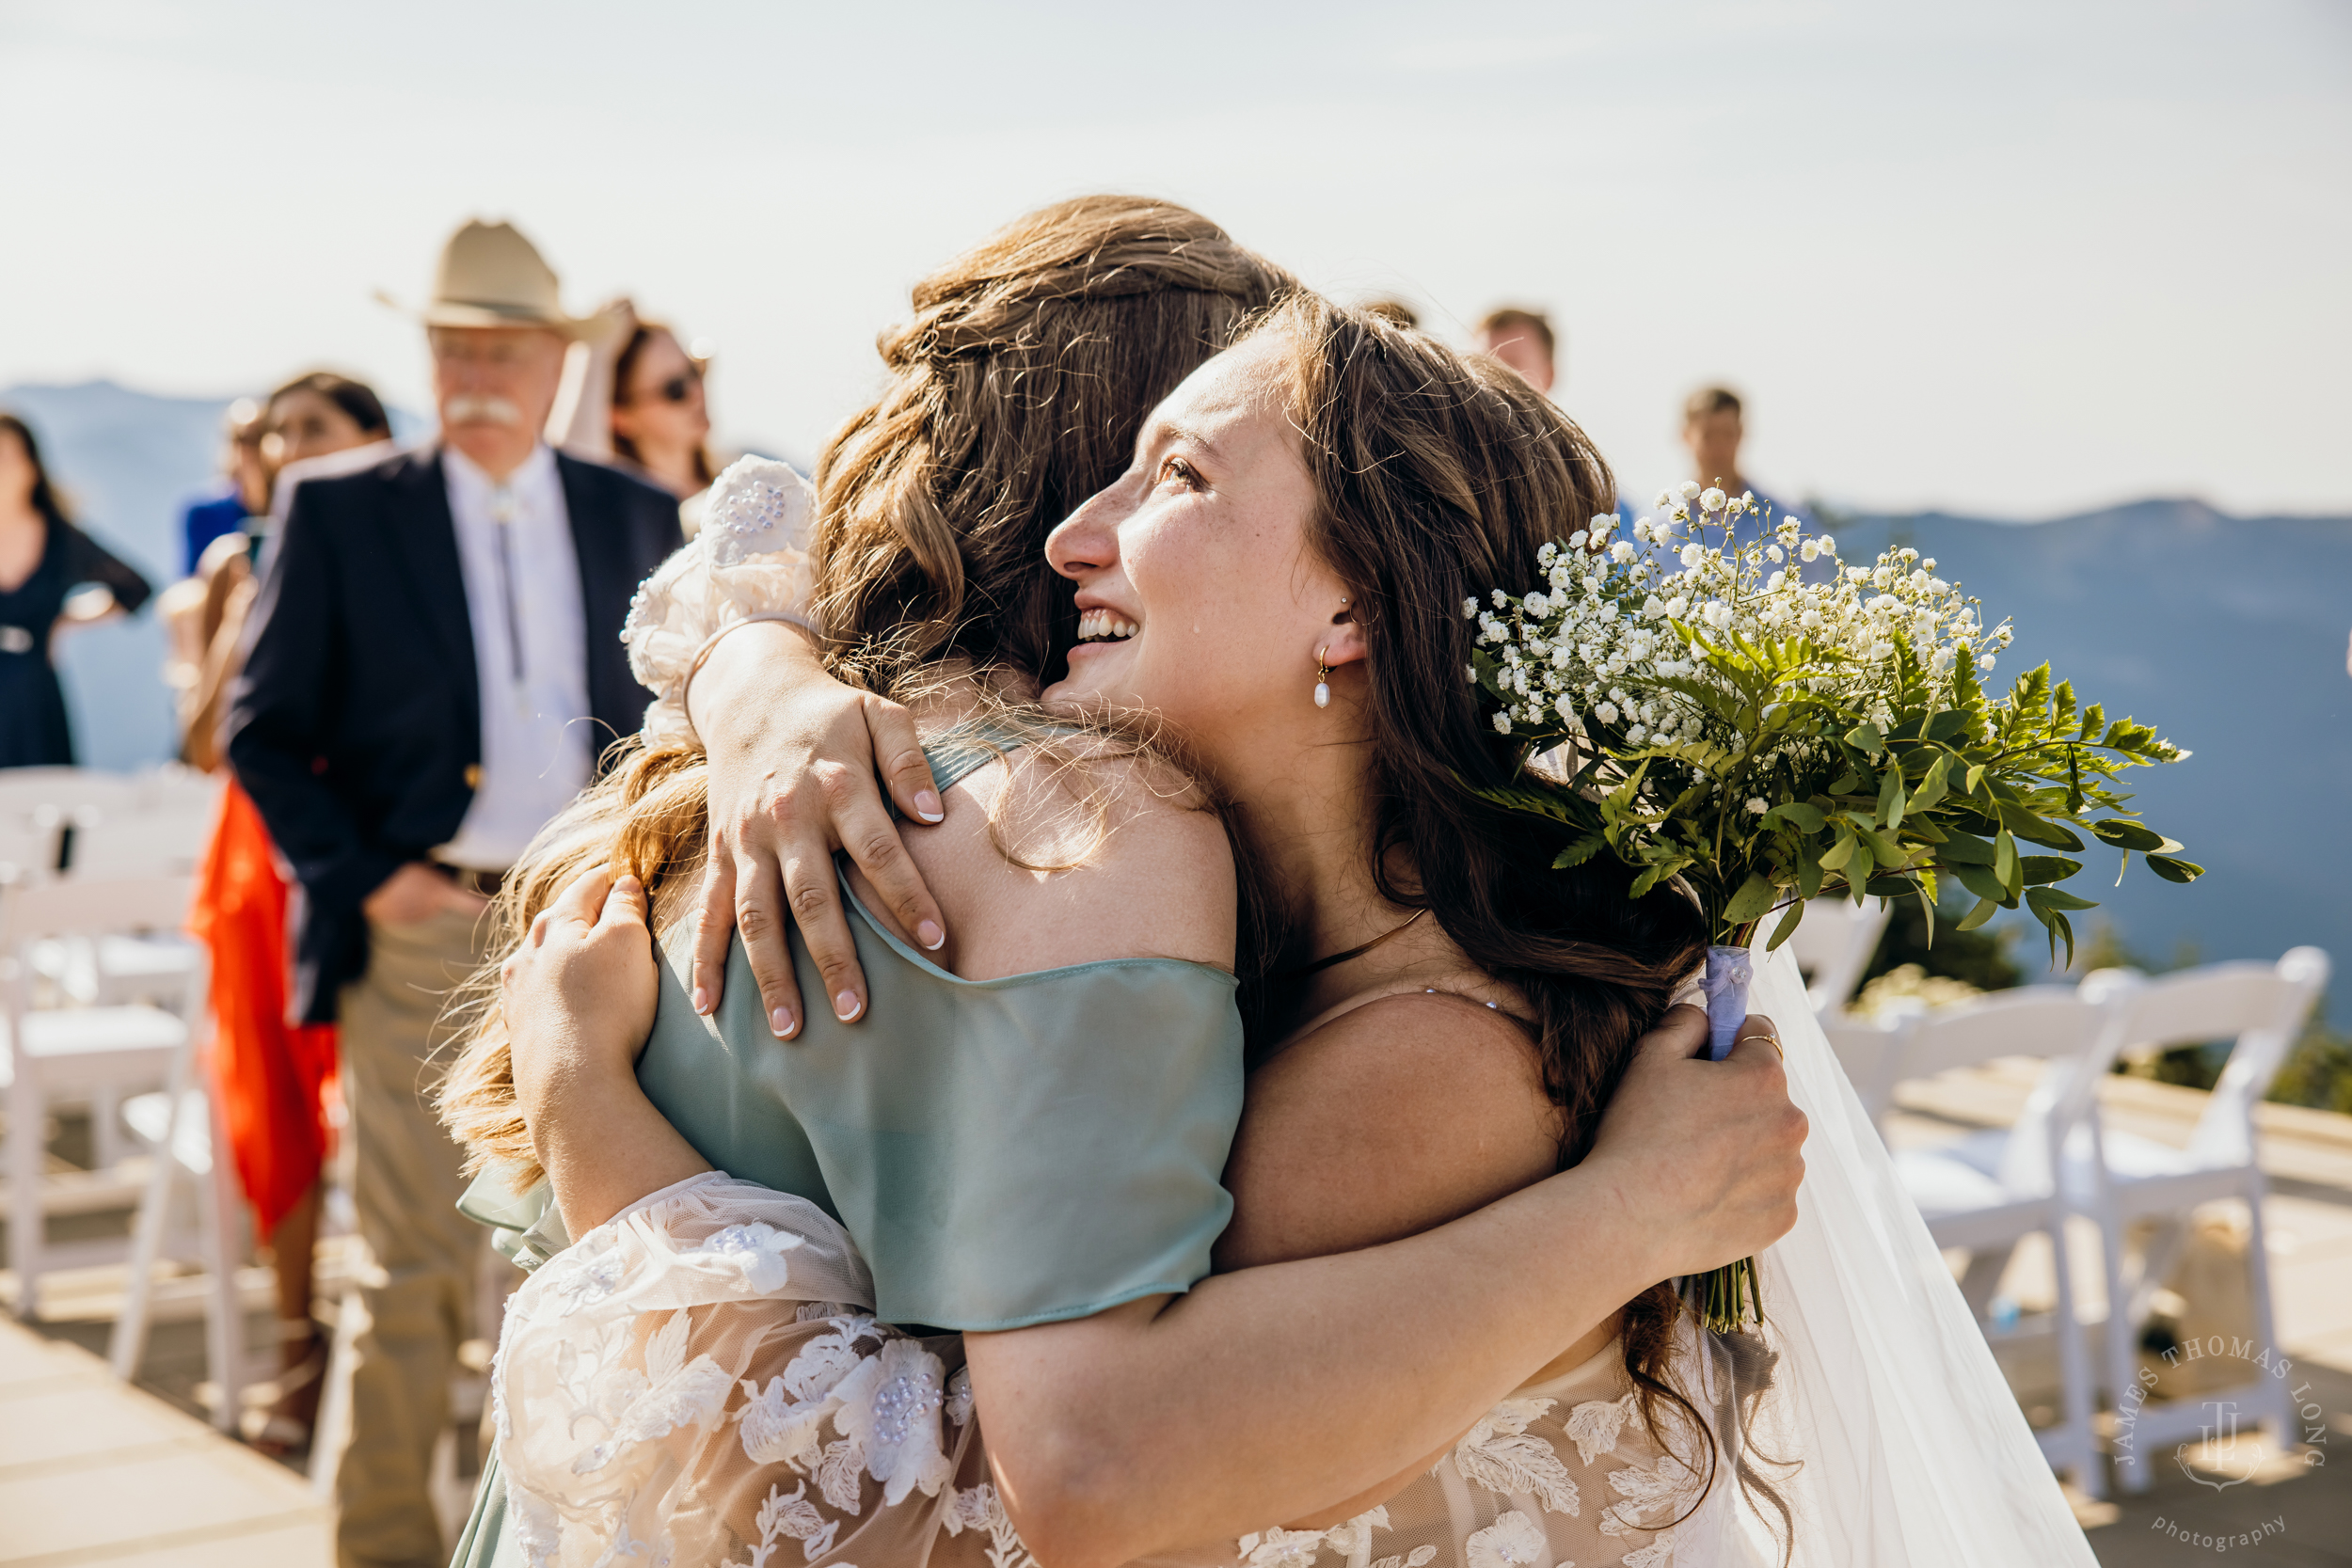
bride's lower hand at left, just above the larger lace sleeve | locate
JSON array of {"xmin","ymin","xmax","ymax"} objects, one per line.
[{"xmin": 499, "ymin": 867, "xmax": 661, "ymax": 1133}]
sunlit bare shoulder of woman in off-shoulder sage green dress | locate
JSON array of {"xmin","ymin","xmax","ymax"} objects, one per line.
[{"xmin": 908, "ymin": 740, "xmax": 1235, "ymax": 980}]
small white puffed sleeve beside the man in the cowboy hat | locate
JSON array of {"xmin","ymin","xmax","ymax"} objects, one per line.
[{"xmin": 621, "ymin": 458, "xmax": 817, "ymax": 748}]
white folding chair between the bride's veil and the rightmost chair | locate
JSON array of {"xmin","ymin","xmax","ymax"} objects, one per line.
[{"xmin": 1886, "ymin": 985, "xmax": 2112, "ymax": 1497}]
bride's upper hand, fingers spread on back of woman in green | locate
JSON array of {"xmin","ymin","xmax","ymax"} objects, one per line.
[{"xmin": 687, "ymin": 621, "xmax": 948, "ymax": 1039}]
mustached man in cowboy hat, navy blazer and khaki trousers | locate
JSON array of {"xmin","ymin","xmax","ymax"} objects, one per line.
[{"xmin": 229, "ymin": 223, "xmax": 680, "ymax": 1568}]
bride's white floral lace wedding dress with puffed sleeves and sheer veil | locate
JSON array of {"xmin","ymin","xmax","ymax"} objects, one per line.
[{"xmin": 541, "ymin": 458, "xmax": 2096, "ymax": 1568}]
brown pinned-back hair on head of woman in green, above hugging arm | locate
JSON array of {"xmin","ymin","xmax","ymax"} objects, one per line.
[{"xmin": 812, "ymin": 195, "xmax": 1296, "ymax": 689}]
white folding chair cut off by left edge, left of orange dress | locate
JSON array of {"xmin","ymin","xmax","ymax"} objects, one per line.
[{"xmin": 0, "ymin": 877, "xmax": 205, "ymax": 1319}]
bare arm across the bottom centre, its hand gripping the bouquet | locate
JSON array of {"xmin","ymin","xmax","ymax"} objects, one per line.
[{"xmin": 967, "ymin": 1008, "xmax": 1804, "ymax": 1568}]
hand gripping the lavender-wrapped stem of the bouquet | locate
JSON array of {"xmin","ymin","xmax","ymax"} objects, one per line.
[{"xmin": 1583, "ymin": 1006, "xmax": 1806, "ymax": 1279}]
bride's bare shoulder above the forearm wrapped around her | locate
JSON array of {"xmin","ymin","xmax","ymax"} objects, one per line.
[{"xmin": 1216, "ymin": 992, "xmax": 1560, "ymax": 1270}]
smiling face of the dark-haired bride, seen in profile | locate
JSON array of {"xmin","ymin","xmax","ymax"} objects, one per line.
[{"xmin": 1044, "ymin": 336, "xmax": 1362, "ymax": 768}]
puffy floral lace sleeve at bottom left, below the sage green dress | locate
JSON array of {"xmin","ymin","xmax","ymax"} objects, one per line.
[{"xmin": 492, "ymin": 1171, "xmax": 1030, "ymax": 1568}]
